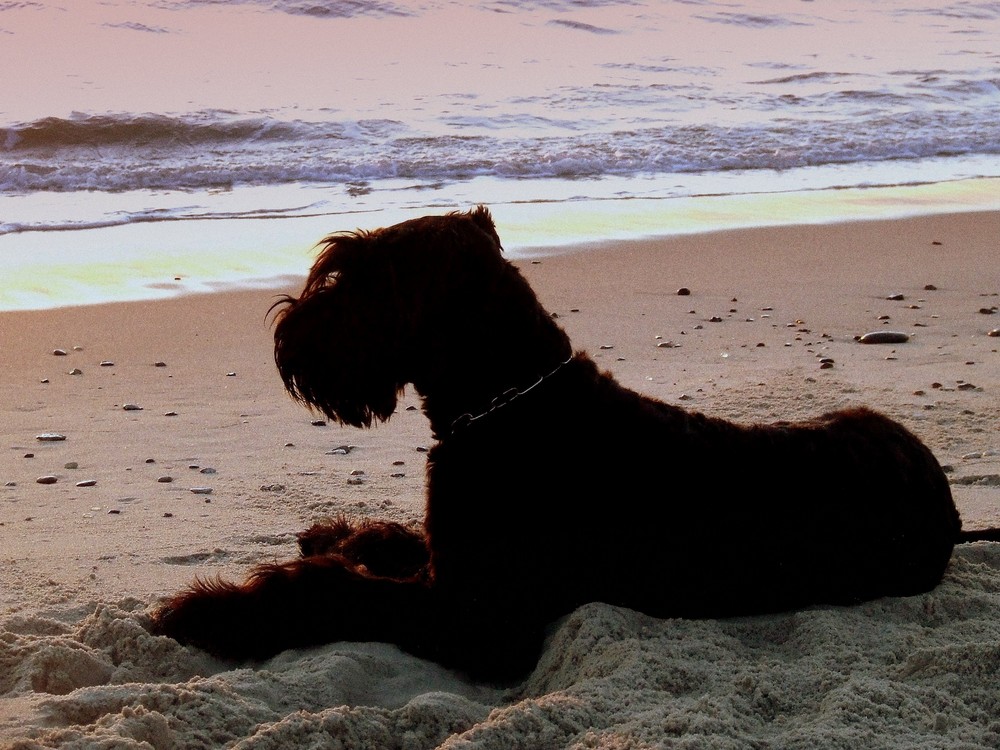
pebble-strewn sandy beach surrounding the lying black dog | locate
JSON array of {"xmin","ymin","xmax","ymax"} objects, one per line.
[{"xmin": 0, "ymin": 213, "xmax": 1000, "ymax": 750}]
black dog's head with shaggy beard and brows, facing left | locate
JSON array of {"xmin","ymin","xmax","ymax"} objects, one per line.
[{"xmin": 274, "ymin": 207, "xmax": 508, "ymax": 427}]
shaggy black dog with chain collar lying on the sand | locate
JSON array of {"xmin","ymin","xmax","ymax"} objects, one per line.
[{"xmin": 154, "ymin": 208, "xmax": 980, "ymax": 678}]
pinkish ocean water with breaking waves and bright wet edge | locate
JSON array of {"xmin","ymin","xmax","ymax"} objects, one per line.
[{"xmin": 0, "ymin": 0, "xmax": 1000, "ymax": 309}]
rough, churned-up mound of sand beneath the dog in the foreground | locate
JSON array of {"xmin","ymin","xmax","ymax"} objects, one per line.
[{"xmin": 0, "ymin": 544, "xmax": 1000, "ymax": 750}]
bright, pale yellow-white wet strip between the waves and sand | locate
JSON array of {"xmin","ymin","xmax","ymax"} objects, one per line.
[{"xmin": 0, "ymin": 178, "xmax": 1000, "ymax": 311}]
